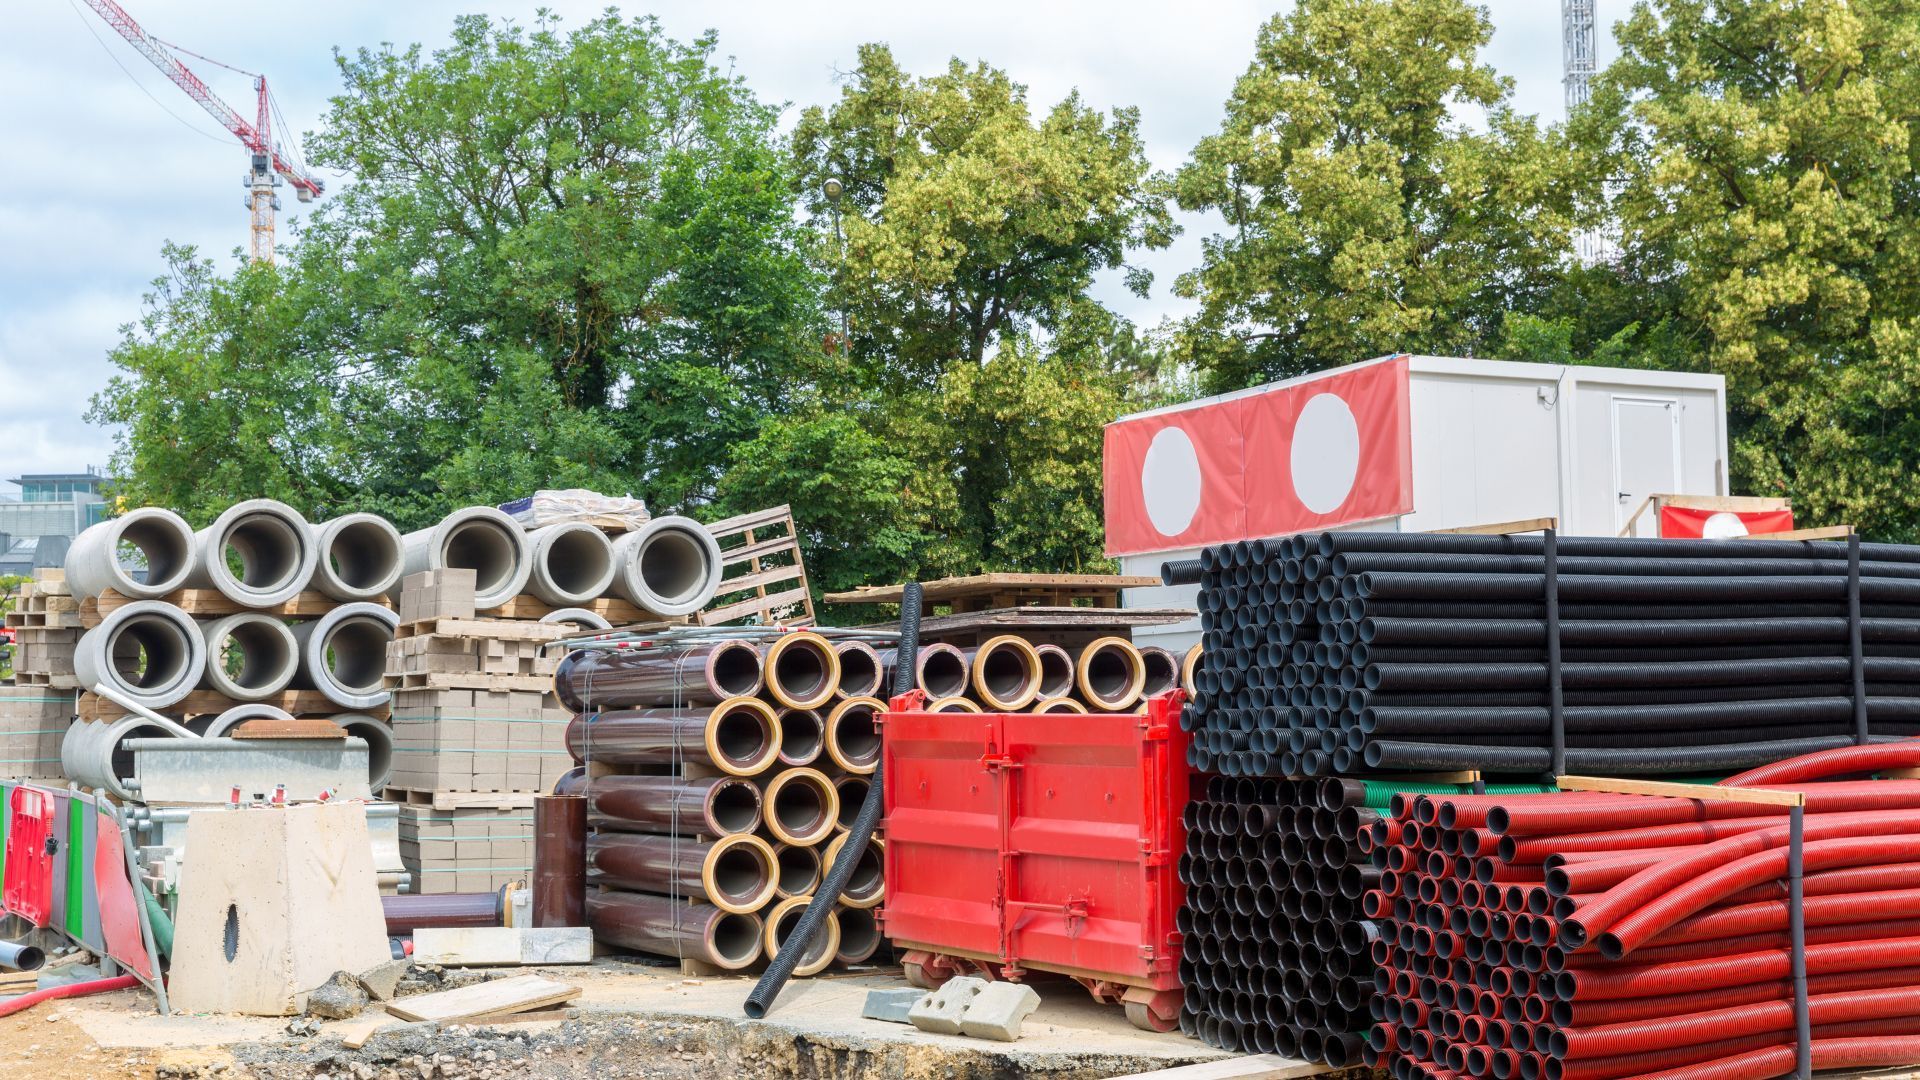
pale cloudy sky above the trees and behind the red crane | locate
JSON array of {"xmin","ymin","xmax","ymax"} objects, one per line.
[{"xmin": 0, "ymin": 0, "xmax": 1626, "ymax": 494}]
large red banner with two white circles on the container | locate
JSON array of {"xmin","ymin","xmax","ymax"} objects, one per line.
[{"xmin": 1106, "ymin": 356, "xmax": 1413, "ymax": 555}]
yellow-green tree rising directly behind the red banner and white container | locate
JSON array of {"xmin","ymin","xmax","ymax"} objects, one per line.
[{"xmin": 1175, "ymin": 0, "xmax": 1574, "ymax": 390}]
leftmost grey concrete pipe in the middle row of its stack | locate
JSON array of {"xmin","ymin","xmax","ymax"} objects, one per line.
[{"xmin": 73, "ymin": 600, "xmax": 207, "ymax": 709}]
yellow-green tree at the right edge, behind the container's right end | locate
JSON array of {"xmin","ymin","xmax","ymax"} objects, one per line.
[{"xmin": 1572, "ymin": 0, "xmax": 1920, "ymax": 540}]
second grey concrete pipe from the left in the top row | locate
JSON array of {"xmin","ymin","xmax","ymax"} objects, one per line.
[{"xmin": 186, "ymin": 500, "xmax": 319, "ymax": 607}]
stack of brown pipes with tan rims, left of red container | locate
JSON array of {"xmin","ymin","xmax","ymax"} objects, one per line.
[{"xmin": 555, "ymin": 630, "xmax": 885, "ymax": 976}]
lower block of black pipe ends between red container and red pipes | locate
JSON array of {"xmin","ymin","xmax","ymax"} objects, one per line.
[{"xmin": 1179, "ymin": 776, "xmax": 1380, "ymax": 1068}]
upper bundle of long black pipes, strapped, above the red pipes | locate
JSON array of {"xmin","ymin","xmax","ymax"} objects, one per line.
[{"xmin": 1164, "ymin": 532, "xmax": 1920, "ymax": 776}]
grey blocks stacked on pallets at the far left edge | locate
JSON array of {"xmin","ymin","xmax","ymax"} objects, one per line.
[{"xmin": 0, "ymin": 569, "xmax": 81, "ymax": 776}]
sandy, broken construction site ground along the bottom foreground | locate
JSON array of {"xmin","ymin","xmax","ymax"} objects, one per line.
[{"xmin": 0, "ymin": 961, "xmax": 1229, "ymax": 1080}]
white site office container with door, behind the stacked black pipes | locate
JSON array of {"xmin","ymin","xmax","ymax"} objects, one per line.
[{"xmin": 1108, "ymin": 356, "xmax": 1728, "ymax": 648}]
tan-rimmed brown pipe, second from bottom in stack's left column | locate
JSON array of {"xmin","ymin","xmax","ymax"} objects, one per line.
[{"xmin": 588, "ymin": 832, "xmax": 776, "ymax": 915}]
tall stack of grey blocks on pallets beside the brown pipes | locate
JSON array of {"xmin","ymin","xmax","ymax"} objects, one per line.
[{"xmin": 386, "ymin": 569, "xmax": 572, "ymax": 894}]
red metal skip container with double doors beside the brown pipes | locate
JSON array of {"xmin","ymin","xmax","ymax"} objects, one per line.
[{"xmin": 879, "ymin": 690, "xmax": 1190, "ymax": 1030}]
